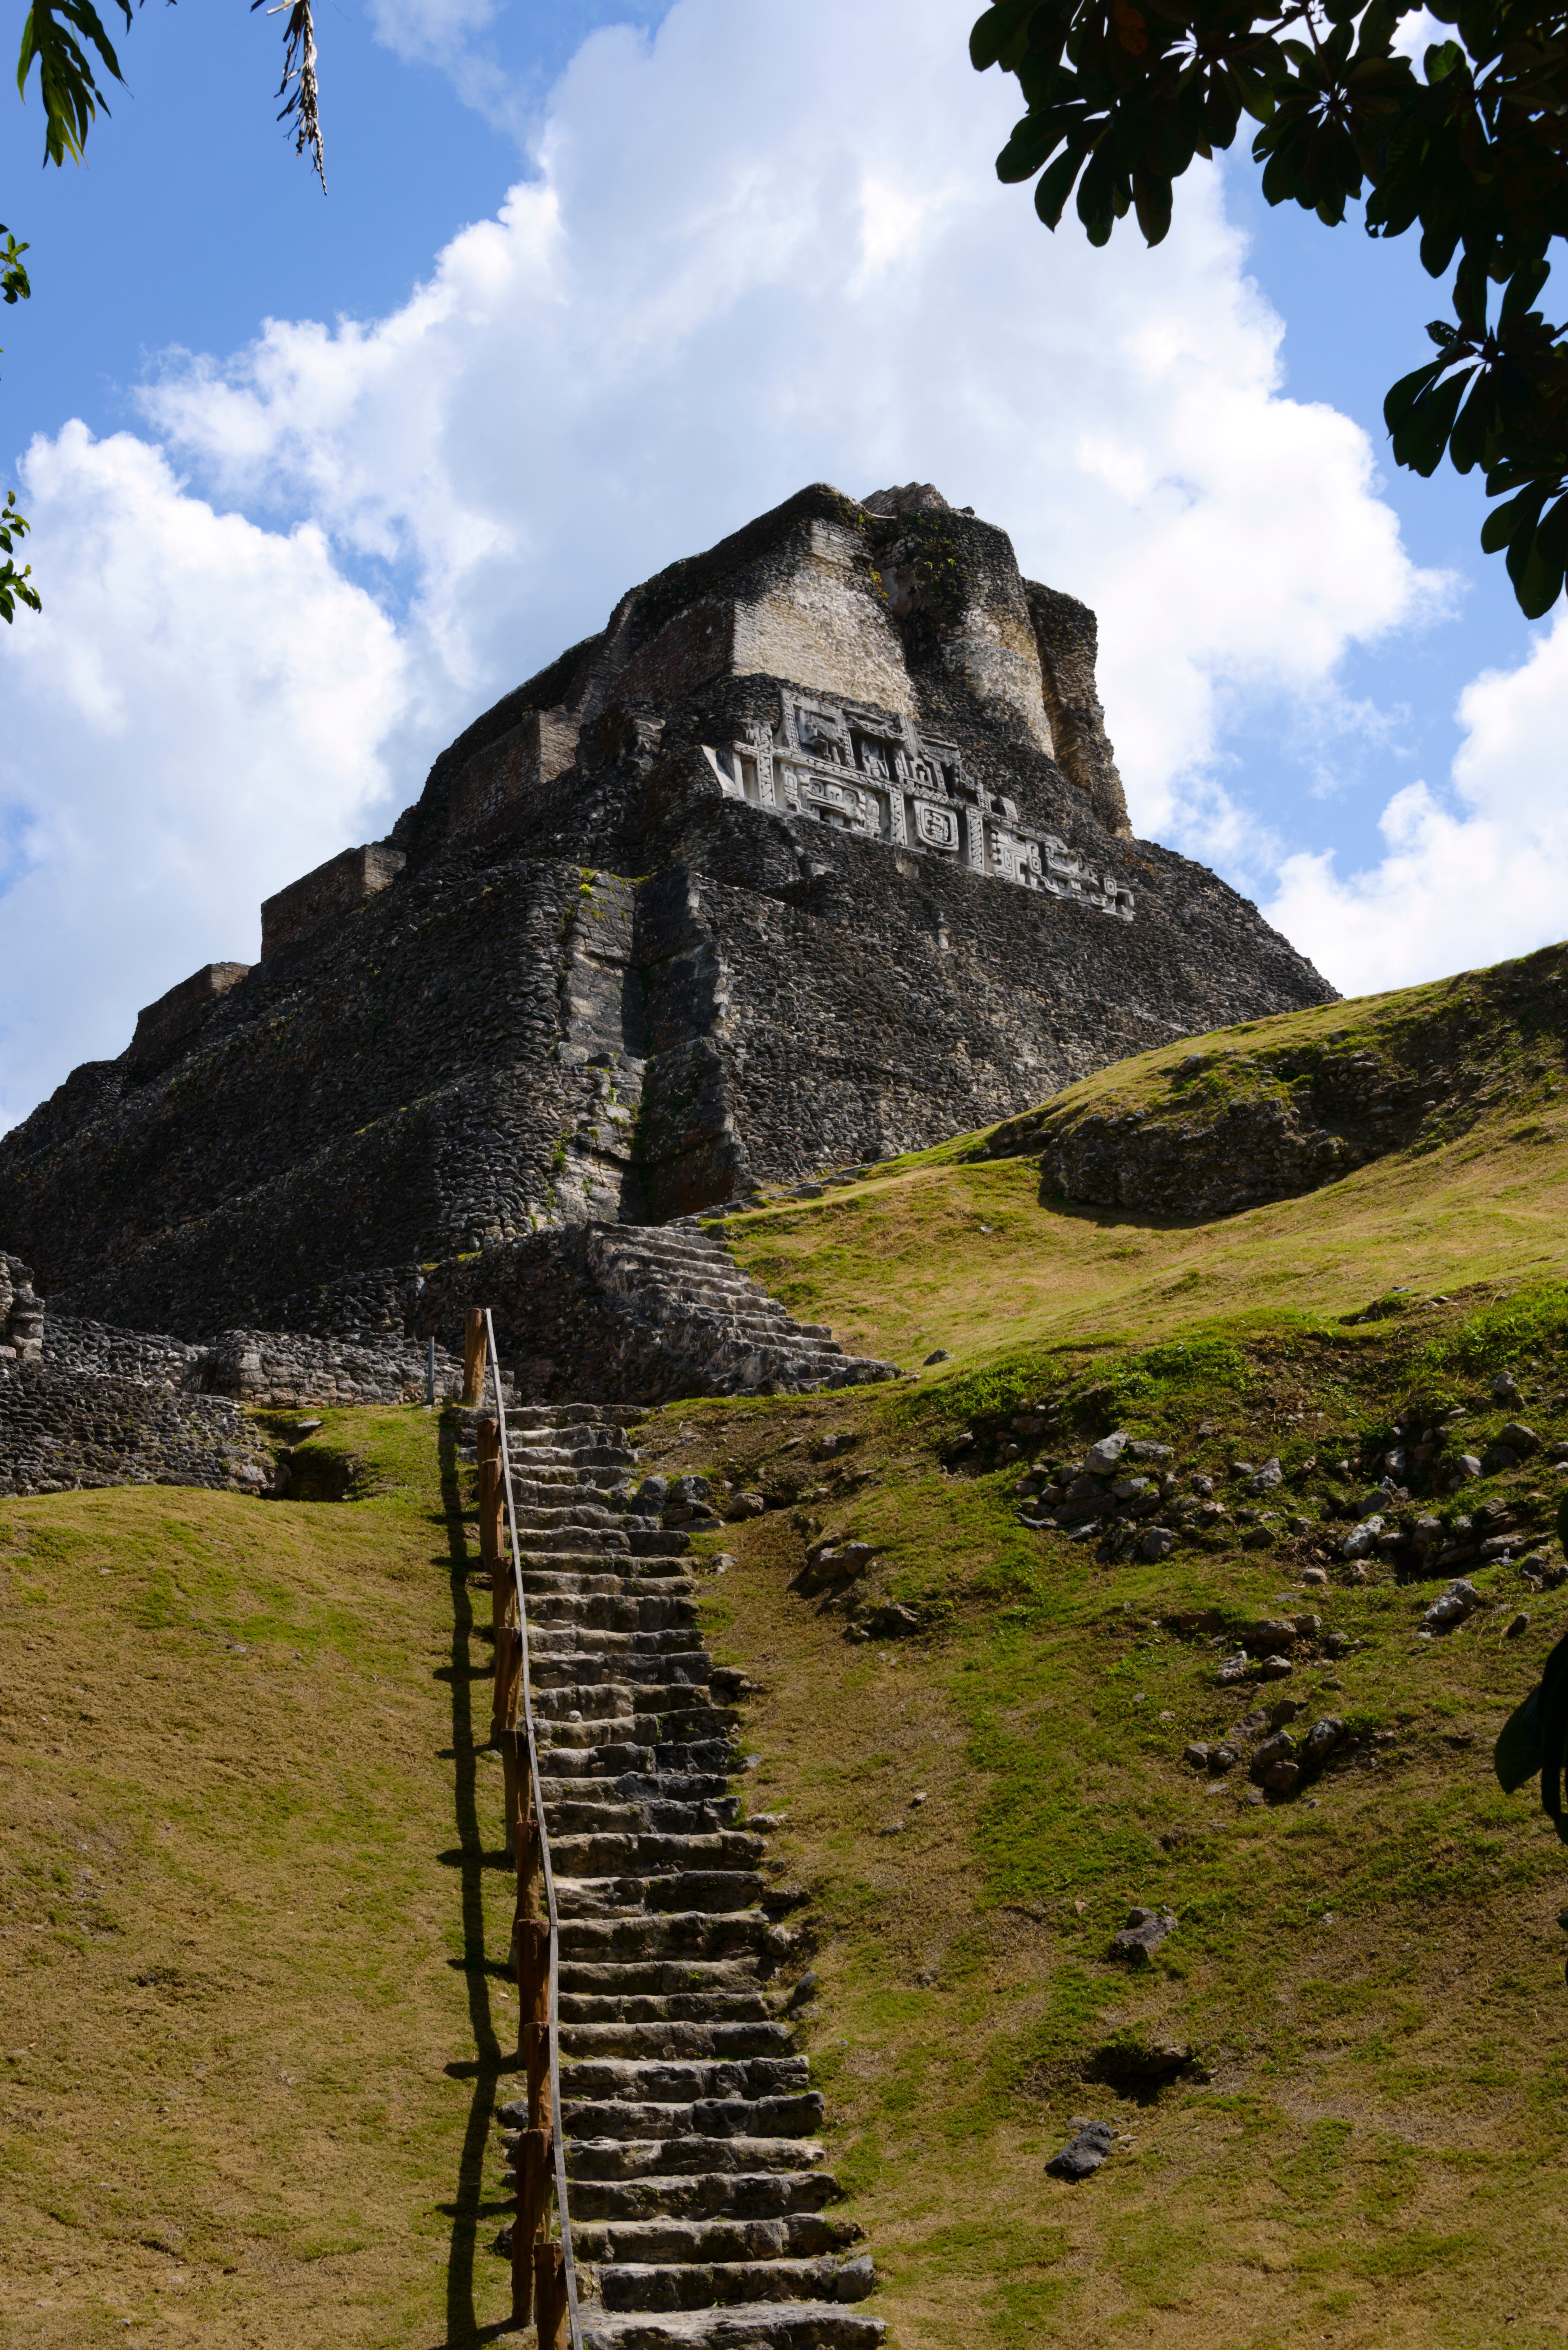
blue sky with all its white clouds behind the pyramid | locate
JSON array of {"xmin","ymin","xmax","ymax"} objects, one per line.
[{"xmin": 0, "ymin": 0, "xmax": 1568, "ymax": 1118}]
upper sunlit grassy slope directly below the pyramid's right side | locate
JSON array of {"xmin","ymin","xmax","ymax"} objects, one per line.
[{"xmin": 727, "ymin": 949, "xmax": 1568, "ymax": 1363}]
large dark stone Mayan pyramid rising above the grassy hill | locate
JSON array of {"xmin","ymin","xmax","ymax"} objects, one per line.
[{"xmin": 0, "ymin": 484, "xmax": 1333, "ymax": 1335}]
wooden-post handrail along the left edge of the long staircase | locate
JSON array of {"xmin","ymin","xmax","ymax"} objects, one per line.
[{"xmin": 479, "ymin": 1307, "xmax": 583, "ymax": 2350}]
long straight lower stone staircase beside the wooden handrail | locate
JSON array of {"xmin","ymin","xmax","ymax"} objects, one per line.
[{"xmin": 503, "ymin": 1405, "xmax": 884, "ymax": 2350}]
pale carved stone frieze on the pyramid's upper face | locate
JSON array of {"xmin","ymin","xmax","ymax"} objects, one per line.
[{"xmin": 703, "ymin": 693, "xmax": 1133, "ymax": 921}]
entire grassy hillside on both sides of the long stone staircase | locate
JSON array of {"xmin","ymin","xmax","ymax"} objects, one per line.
[{"xmin": 0, "ymin": 957, "xmax": 1568, "ymax": 2350}]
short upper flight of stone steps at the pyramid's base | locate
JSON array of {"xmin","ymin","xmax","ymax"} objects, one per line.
[{"xmin": 588, "ymin": 1222, "xmax": 898, "ymax": 1396}]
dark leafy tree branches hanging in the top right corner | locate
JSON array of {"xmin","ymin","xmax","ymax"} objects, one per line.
[{"xmin": 969, "ymin": 0, "xmax": 1568, "ymax": 618}]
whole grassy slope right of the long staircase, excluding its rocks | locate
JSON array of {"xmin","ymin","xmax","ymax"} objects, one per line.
[{"xmin": 616, "ymin": 954, "xmax": 1568, "ymax": 2350}]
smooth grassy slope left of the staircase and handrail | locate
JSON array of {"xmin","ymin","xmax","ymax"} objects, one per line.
[{"xmin": 0, "ymin": 1412, "xmax": 515, "ymax": 2350}]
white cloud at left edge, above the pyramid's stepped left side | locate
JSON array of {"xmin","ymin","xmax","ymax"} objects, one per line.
[{"xmin": 0, "ymin": 423, "xmax": 407, "ymax": 1121}]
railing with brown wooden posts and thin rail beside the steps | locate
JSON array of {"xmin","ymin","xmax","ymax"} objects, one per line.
[{"xmin": 463, "ymin": 1307, "xmax": 583, "ymax": 2350}]
